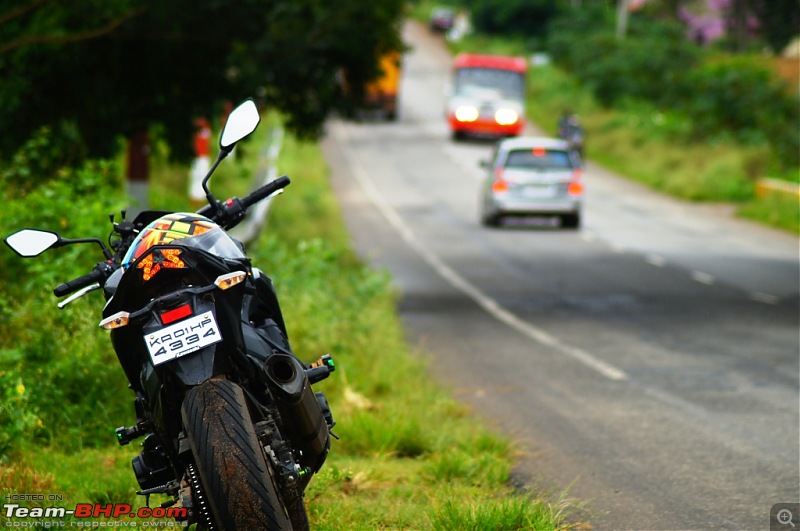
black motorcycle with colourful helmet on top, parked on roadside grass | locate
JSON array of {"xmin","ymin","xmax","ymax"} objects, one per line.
[{"xmin": 5, "ymin": 100, "xmax": 334, "ymax": 531}]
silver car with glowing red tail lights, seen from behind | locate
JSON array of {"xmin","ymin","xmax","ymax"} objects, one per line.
[{"xmin": 480, "ymin": 137, "xmax": 583, "ymax": 229}]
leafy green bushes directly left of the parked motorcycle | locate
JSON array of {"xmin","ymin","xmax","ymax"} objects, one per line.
[{"xmin": 0, "ymin": 129, "xmax": 130, "ymax": 457}]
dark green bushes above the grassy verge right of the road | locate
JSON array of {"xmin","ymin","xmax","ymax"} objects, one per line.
[{"xmin": 548, "ymin": 5, "xmax": 800, "ymax": 170}]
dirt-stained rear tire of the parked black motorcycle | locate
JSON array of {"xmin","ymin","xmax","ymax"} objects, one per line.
[{"xmin": 181, "ymin": 380, "xmax": 292, "ymax": 531}]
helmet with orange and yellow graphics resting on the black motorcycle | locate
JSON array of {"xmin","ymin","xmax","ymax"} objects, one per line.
[{"xmin": 122, "ymin": 212, "xmax": 245, "ymax": 269}]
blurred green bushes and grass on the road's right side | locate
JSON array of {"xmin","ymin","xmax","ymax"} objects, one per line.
[{"xmin": 413, "ymin": 0, "xmax": 800, "ymax": 233}]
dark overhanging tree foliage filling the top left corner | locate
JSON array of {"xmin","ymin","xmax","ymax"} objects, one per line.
[{"xmin": 0, "ymin": 0, "xmax": 403, "ymax": 164}]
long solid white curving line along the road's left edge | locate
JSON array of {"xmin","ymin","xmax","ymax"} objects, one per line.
[{"xmin": 333, "ymin": 124, "xmax": 628, "ymax": 381}]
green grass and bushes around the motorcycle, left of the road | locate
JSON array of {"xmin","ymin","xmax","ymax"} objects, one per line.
[{"xmin": 0, "ymin": 116, "xmax": 576, "ymax": 530}]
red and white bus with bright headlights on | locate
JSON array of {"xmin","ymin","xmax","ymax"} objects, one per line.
[{"xmin": 447, "ymin": 53, "xmax": 528, "ymax": 139}]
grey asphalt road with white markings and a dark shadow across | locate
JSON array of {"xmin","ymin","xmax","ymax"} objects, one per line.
[{"xmin": 323, "ymin": 22, "xmax": 800, "ymax": 529}]
